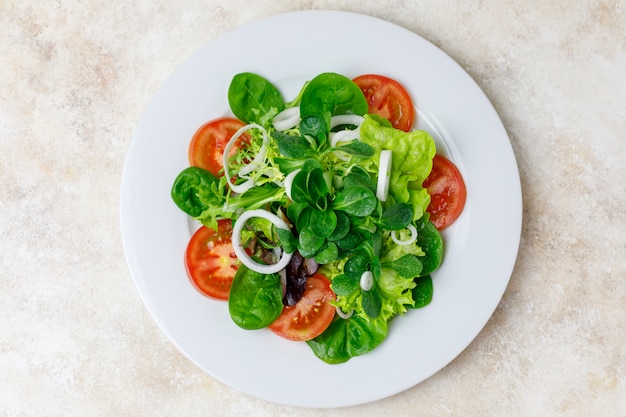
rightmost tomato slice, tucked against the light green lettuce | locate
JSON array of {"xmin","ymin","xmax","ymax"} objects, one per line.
[{"xmin": 422, "ymin": 154, "xmax": 467, "ymax": 230}]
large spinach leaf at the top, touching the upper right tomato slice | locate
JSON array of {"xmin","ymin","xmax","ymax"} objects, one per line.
[{"xmin": 300, "ymin": 72, "xmax": 368, "ymax": 118}]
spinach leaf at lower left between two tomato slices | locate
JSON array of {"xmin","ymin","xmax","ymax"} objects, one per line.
[{"xmin": 228, "ymin": 265, "xmax": 283, "ymax": 330}]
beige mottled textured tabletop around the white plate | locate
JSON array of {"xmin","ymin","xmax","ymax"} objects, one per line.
[{"xmin": 0, "ymin": 0, "xmax": 626, "ymax": 417}]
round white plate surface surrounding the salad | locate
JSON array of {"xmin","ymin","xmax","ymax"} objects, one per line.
[{"xmin": 121, "ymin": 11, "xmax": 522, "ymax": 407}]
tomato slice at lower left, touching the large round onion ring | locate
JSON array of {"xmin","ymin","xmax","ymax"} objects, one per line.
[{"xmin": 185, "ymin": 220, "xmax": 239, "ymax": 300}]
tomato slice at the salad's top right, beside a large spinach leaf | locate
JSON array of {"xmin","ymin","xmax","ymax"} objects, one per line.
[{"xmin": 352, "ymin": 74, "xmax": 415, "ymax": 132}]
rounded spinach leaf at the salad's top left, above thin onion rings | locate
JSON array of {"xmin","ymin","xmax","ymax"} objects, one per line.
[{"xmin": 228, "ymin": 72, "xmax": 285, "ymax": 127}]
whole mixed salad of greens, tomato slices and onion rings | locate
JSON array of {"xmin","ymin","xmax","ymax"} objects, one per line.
[{"xmin": 171, "ymin": 72, "xmax": 466, "ymax": 364}]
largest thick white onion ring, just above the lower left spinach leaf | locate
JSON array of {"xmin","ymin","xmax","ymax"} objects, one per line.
[{"xmin": 232, "ymin": 209, "xmax": 291, "ymax": 274}]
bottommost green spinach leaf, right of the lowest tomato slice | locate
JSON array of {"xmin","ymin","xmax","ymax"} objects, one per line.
[{"xmin": 307, "ymin": 316, "xmax": 388, "ymax": 364}]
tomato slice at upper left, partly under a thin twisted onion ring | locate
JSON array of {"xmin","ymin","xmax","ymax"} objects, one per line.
[{"xmin": 189, "ymin": 117, "xmax": 248, "ymax": 177}]
